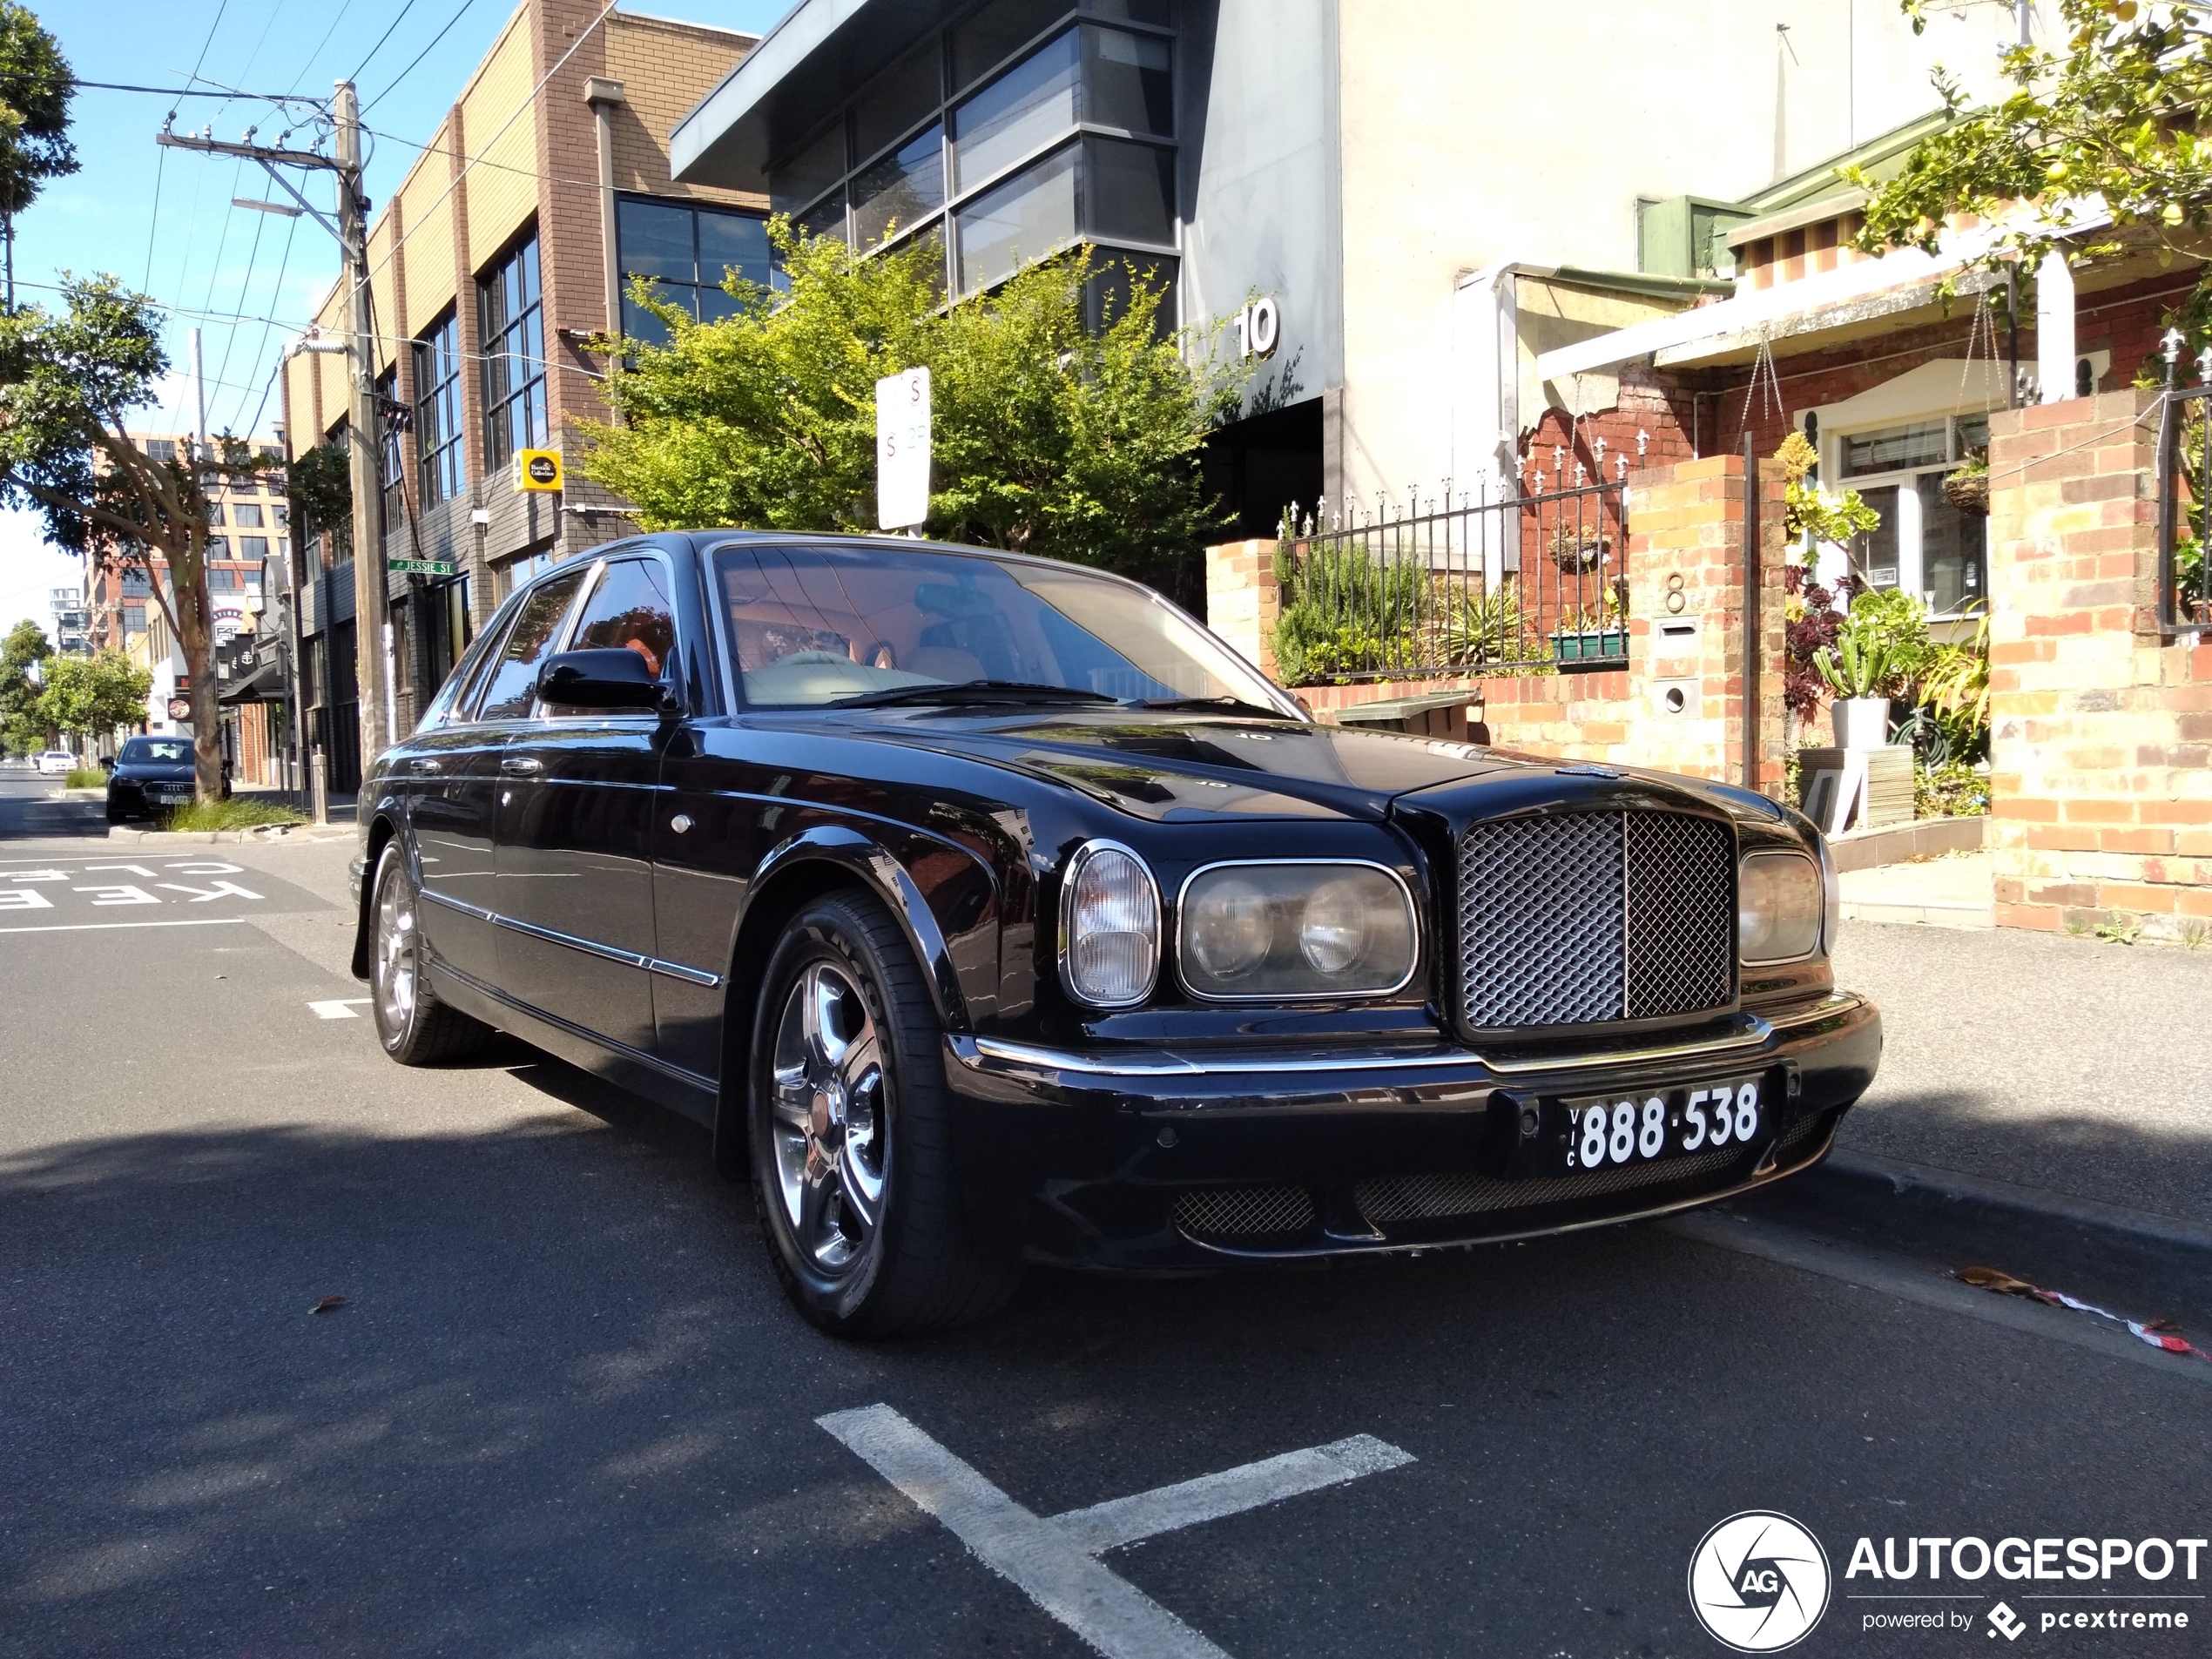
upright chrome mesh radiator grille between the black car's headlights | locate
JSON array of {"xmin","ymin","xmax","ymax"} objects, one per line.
[{"xmin": 1460, "ymin": 812, "xmax": 1737, "ymax": 1031}]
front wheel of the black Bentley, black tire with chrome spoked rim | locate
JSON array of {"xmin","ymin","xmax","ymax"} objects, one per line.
[{"xmin": 745, "ymin": 892, "xmax": 1022, "ymax": 1336}]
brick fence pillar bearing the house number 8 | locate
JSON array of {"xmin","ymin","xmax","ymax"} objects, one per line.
[{"xmin": 1628, "ymin": 455, "xmax": 1785, "ymax": 799}]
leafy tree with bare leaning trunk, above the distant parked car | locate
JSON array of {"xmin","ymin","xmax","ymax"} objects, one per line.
[{"xmin": 0, "ymin": 277, "xmax": 259, "ymax": 800}]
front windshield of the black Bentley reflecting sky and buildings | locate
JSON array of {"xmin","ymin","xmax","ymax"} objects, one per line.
[{"xmin": 714, "ymin": 544, "xmax": 1283, "ymax": 710}]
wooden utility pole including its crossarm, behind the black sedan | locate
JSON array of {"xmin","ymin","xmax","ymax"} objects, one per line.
[{"xmin": 155, "ymin": 92, "xmax": 392, "ymax": 787}]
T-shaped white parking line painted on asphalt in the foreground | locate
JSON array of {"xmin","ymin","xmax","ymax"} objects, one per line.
[{"xmin": 816, "ymin": 1405, "xmax": 1413, "ymax": 1659}]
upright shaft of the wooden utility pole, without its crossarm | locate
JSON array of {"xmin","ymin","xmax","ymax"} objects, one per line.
[{"xmin": 329, "ymin": 79, "xmax": 392, "ymax": 777}]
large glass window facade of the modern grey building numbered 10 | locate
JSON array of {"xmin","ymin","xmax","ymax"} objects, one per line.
[{"xmin": 767, "ymin": 0, "xmax": 1179, "ymax": 325}]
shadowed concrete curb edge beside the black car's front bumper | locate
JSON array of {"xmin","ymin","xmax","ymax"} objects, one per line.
[{"xmin": 1781, "ymin": 1152, "xmax": 2212, "ymax": 1270}]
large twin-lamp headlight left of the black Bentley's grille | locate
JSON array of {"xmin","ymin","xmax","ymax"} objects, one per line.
[{"xmin": 1177, "ymin": 860, "xmax": 1420, "ymax": 1000}]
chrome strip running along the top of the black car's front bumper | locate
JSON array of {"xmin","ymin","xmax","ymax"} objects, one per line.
[{"xmin": 945, "ymin": 991, "xmax": 1863, "ymax": 1080}]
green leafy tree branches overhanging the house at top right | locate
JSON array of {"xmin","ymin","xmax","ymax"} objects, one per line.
[{"xmin": 1844, "ymin": 0, "xmax": 2212, "ymax": 365}]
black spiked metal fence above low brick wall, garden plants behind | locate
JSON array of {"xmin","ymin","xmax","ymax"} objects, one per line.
[{"xmin": 1274, "ymin": 482, "xmax": 1628, "ymax": 685}]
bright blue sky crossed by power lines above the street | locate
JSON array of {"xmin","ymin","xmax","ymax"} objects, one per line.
[{"xmin": 0, "ymin": 0, "xmax": 787, "ymax": 631}]
